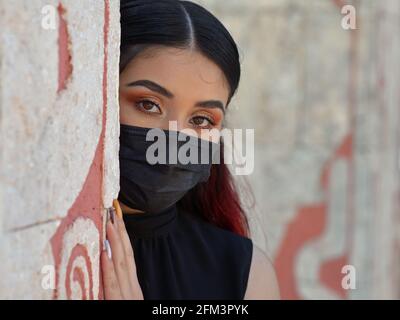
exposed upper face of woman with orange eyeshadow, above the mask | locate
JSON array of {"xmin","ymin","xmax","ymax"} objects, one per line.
[{"xmin": 119, "ymin": 47, "xmax": 229, "ymax": 134}]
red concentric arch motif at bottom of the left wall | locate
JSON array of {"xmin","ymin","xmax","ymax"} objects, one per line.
[{"xmin": 65, "ymin": 244, "xmax": 93, "ymax": 300}]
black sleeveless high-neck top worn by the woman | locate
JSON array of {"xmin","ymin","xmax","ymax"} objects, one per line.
[{"xmin": 123, "ymin": 205, "xmax": 253, "ymax": 299}]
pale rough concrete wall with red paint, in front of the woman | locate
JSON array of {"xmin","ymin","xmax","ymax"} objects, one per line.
[{"xmin": 0, "ymin": 0, "xmax": 120, "ymax": 299}]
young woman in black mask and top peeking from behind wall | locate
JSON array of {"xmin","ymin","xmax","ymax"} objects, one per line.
[{"xmin": 101, "ymin": 0, "xmax": 279, "ymax": 299}]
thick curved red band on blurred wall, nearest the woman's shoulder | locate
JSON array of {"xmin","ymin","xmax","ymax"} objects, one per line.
[{"xmin": 275, "ymin": 203, "xmax": 326, "ymax": 300}]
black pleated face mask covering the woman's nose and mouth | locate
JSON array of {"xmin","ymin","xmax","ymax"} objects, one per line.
[{"xmin": 118, "ymin": 124, "xmax": 220, "ymax": 213}]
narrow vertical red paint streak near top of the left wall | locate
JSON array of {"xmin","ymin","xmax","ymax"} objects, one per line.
[{"xmin": 57, "ymin": 3, "xmax": 72, "ymax": 93}]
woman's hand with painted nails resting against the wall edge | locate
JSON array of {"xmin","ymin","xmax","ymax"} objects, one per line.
[{"xmin": 101, "ymin": 209, "xmax": 143, "ymax": 300}]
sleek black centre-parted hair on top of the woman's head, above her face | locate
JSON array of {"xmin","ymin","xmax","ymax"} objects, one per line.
[{"xmin": 120, "ymin": 0, "xmax": 240, "ymax": 104}]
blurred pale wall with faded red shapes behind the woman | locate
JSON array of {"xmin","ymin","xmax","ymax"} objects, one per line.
[{"xmin": 196, "ymin": 0, "xmax": 400, "ymax": 299}]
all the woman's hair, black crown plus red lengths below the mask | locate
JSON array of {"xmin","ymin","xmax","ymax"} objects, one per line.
[{"xmin": 120, "ymin": 0, "xmax": 249, "ymax": 236}]
